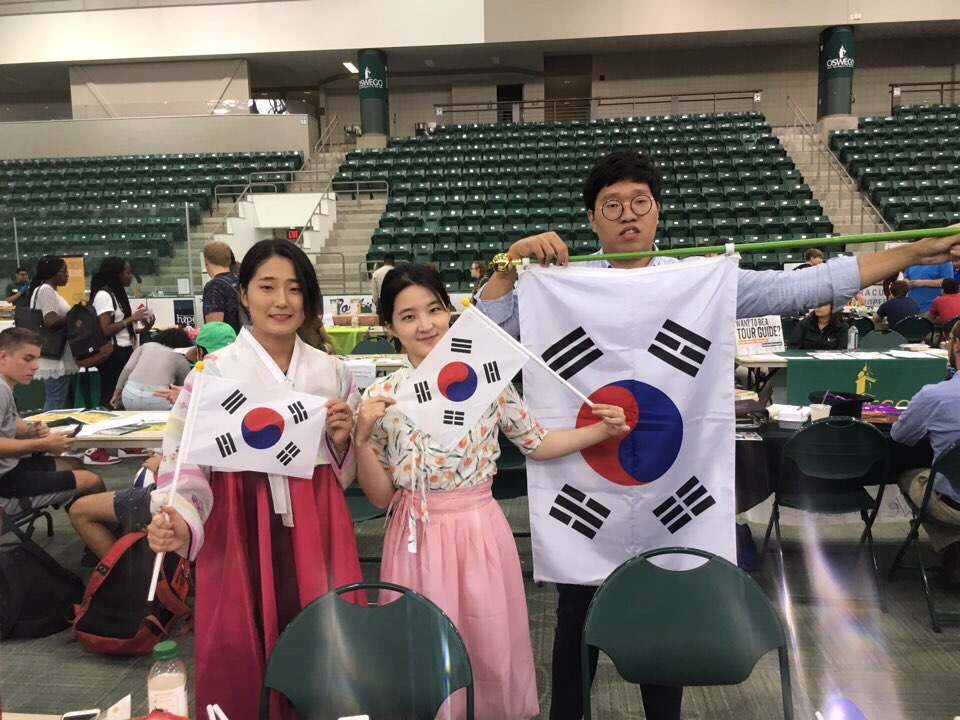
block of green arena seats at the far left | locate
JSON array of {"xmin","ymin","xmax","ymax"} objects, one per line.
[{"xmin": 0, "ymin": 151, "xmax": 303, "ymax": 275}]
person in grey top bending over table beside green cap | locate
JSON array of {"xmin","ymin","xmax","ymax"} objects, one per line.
[{"xmin": 110, "ymin": 325, "xmax": 192, "ymax": 410}]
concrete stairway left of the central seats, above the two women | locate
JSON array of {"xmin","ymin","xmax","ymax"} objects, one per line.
[{"xmin": 314, "ymin": 193, "xmax": 387, "ymax": 296}]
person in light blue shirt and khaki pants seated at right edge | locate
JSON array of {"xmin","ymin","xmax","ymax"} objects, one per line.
[{"xmin": 890, "ymin": 323, "xmax": 960, "ymax": 588}]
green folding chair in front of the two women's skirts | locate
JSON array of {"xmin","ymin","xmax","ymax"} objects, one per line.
[{"xmin": 259, "ymin": 583, "xmax": 474, "ymax": 720}]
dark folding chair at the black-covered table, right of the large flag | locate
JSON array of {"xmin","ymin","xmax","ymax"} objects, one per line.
[{"xmin": 760, "ymin": 415, "xmax": 890, "ymax": 612}]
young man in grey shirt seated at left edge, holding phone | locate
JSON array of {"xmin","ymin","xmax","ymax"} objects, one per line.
[{"xmin": 0, "ymin": 328, "xmax": 104, "ymax": 515}]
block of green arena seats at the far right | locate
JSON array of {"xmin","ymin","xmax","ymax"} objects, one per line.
[{"xmin": 830, "ymin": 105, "xmax": 960, "ymax": 230}]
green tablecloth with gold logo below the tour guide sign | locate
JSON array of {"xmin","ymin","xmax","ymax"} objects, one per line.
[{"xmin": 778, "ymin": 350, "xmax": 947, "ymax": 405}]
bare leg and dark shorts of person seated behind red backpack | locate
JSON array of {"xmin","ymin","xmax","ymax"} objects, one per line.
[{"xmin": 69, "ymin": 453, "xmax": 160, "ymax": 565}]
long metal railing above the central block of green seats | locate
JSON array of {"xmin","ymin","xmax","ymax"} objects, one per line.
[{"xmin": 433, "ymin": 90, "xmax": 763, "ymax": 125}]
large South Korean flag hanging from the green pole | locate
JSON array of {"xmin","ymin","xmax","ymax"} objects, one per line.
[{"xmin": 517, "ymin": 258, "xmax": 737, "ymax": 585}]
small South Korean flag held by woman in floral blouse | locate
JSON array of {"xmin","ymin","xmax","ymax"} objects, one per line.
[{"xmin": 397, "ymin": 307, "xmax": 529, "ymax": 448}]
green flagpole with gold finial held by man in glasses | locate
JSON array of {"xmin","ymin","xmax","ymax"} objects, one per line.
[{"xmin": 492, "ymin": 227, "xmax": 960, "ymax": 272}]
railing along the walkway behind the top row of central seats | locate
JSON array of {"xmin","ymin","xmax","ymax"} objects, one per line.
[{"xmin": 433, "ymin": 89, "xmax": 763, "ymax": 124}]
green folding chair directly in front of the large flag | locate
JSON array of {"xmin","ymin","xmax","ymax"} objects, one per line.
[{"xmin": 580, "ymin": 548, "xmax": 793, "ymax": 720}]
